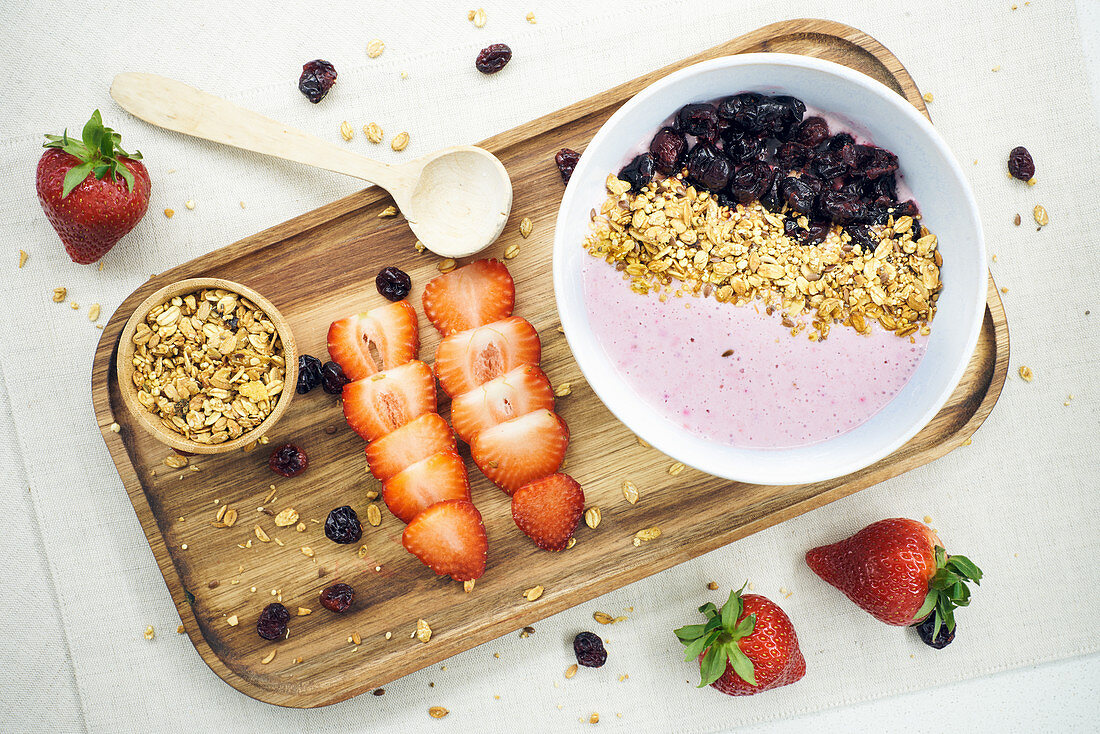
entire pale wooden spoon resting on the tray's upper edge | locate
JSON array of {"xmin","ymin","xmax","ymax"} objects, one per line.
[{"xmin": 111, "ymin": 73, "xmax": 512, "ymax": 258}]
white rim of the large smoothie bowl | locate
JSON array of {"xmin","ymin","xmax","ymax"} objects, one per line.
[{"xmin": 552, "ymin": 52, "xmax": 988, "ymax": 485}]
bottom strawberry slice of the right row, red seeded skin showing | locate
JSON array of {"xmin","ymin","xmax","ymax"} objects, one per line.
[{"xmin": 512, "ymin": 474, "xmax": 584, "ymax": 550}]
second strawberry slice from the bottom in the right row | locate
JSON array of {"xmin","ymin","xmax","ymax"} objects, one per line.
[{"xmin": 470, "ymin": 410, "xmax": 569, "ymax": 494}]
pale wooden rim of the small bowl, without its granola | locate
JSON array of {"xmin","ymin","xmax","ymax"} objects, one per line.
[{"xmin": 116, "ymin": 277, "xmax": 298, "ymax": 453}]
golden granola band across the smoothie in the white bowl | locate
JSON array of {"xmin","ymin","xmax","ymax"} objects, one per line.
[{"xmin": 584, "ymin": 175, "xmax": 943, "ymax": 340}]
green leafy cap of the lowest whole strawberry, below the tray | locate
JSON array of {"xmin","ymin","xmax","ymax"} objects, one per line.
[{"xmin": 674, "ymin": 582, "xmax": 757, "ymax": 688}]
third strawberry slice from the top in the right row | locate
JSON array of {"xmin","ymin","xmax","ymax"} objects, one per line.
[{"xmin": 451, "ymin": 364, "xmax": 553, "ymax": 443}]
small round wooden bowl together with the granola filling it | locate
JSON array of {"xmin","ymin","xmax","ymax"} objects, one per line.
[{"xmin": 116, "ymin": 277, "xmax": 298, "ymax": 453}]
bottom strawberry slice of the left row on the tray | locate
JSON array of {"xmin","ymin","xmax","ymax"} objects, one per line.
[{"xmin": 402, "ymin": 500, "xmax": 488, "ymax": 581}]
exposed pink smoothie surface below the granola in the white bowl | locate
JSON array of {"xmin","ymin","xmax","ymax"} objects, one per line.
[{"xmin": 581, "ymin": 256, "xmax": 927, "ymax": 449}]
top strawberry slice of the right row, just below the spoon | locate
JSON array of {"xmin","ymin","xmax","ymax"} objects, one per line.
[{"xmin": 424, "ymin": 260, "xmax": 516, "ymax": 337}]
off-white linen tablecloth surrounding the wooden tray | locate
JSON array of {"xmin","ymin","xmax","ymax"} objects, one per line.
[{"xmin": 0, "ymin": 0, "xmax": 1100, "ymax": 732}]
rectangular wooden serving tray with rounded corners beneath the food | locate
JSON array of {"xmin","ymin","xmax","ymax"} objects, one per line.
[{"xmin": 91, "ymin": 20, "xmax": 1009, "ymax": 708}]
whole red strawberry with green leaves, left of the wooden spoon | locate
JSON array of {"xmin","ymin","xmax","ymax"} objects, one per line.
[{"xmin": 35, "ymin": 110, "xmax": 150, "ymax": 265}]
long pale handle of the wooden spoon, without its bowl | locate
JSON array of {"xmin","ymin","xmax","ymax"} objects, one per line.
[{"xmin": 111, "ymin": 73, "xmax": 407, "ymax": 196}]
